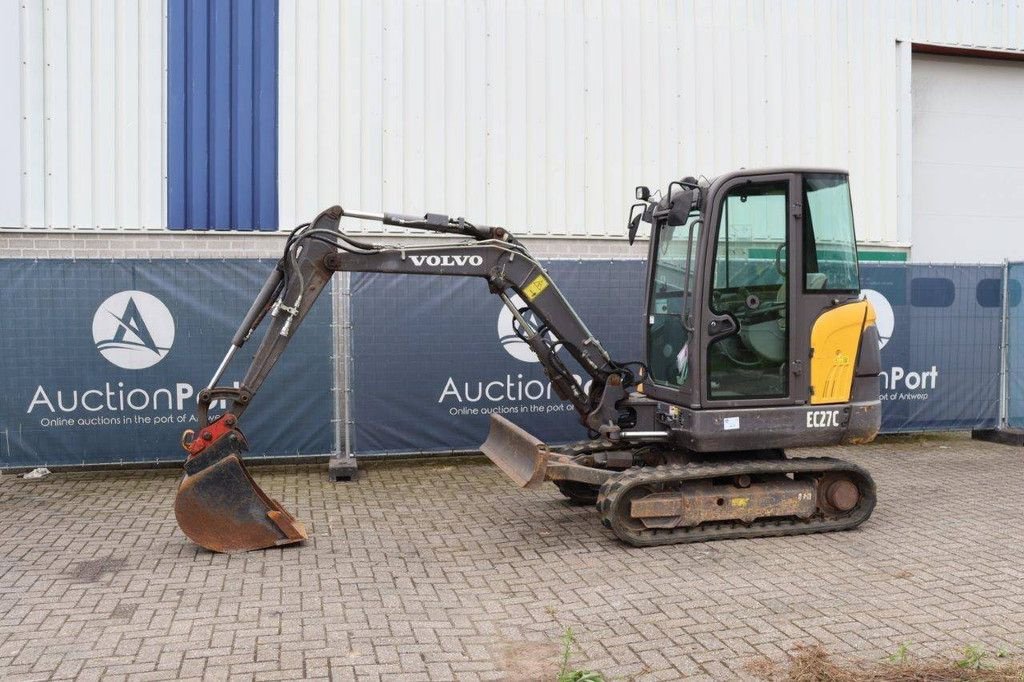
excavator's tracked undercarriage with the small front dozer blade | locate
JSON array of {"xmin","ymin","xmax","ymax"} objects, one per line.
[{"xmin": 482, "ymin": 409, "xmax": 876, "ymax": 547}]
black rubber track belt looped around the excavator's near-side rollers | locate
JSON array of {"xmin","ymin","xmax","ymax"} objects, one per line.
[{"xmin": 597, "ymin": 457, "xmax": 877, "ymax": 547}]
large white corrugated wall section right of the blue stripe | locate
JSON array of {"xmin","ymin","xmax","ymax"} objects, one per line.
[{"xmin": 280, "ymin": 0, "xmax": 1024, "ymax": 245}]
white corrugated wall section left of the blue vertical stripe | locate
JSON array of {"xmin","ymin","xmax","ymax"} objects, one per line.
[{"xmin": 0, "ymin": 0, "xmax": 166, "ymax": 229}]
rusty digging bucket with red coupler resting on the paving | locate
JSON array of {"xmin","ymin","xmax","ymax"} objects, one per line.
[{"xmin": 174, "ymin": 429, "xmax": 307, "ymax": 553}]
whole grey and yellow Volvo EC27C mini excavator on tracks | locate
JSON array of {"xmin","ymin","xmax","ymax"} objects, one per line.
[{"xmin": 175, "ymin": 168, "xmax": 881, "ymax": 552}]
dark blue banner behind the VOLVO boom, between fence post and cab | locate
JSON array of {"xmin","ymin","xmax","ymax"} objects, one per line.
[{"xmin": 349, "ymin": 260, "xmax": 645, "ymax": 454}]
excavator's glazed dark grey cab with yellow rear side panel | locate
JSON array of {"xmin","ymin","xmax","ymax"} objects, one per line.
[{"xmin": 644, "ymin": 169, "xmax": 879, "ymax": 430}]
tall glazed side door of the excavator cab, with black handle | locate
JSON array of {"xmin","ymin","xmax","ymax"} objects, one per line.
[{"xmin": 699, "ymin": 173, "xmax": 808, "ymax": 408}]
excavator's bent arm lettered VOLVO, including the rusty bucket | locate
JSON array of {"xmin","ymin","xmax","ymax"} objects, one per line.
[{"xmin": 175, "ymin": 206, "xmax": 642, "ymax": 552}]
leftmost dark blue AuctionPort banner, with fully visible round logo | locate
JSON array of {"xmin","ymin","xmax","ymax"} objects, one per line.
[{"xmin": 0, "ymin": 260, "xmax": 334, "ymax": 468}]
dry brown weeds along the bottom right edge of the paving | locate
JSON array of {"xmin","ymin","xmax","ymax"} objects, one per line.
[{"xmin": 749, "ymin": 643, "xmax": 1024, "ymax": 682}]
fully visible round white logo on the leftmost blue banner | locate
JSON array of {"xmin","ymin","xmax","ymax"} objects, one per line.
[{"xmin": 92, "ymin": 291, "xmax": 174, "ymax": 370}]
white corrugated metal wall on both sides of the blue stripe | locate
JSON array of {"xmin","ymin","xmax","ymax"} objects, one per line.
[{"xmin": 0, "ymin": 0, "xmax": 1024, "ymax": 240}]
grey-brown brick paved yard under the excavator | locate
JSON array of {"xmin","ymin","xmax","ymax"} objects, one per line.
[{"xmin": 0, "ymin": 437, "xmax": 1024, "ymax": 680}]
